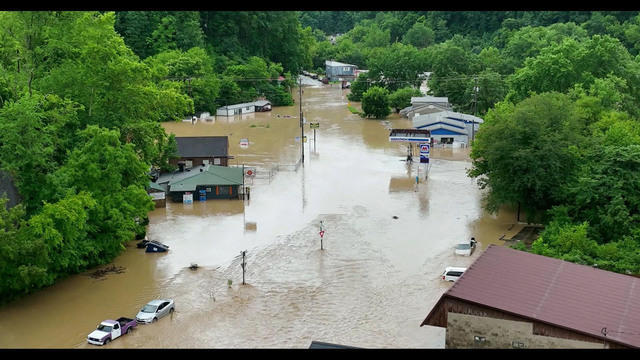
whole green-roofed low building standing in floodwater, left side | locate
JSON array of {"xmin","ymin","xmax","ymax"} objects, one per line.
[{"xmin": 156, "ymin": 164, "xmax": 244, "ymax": 202}]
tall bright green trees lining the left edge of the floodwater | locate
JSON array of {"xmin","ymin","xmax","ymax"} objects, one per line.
[{"xmin": 0, "ymin": 12, "xmax": 185, "ymax": 301}]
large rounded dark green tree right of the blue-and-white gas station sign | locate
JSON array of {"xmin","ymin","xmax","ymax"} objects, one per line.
[{"xmin": 469, "ymin": 93, "xmax": 581, "ymax": 219}]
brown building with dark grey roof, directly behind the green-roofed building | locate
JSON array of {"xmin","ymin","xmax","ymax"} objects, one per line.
[{"xmin": 169, "ymin": 136, "xmax": 232, "ymax": 169}]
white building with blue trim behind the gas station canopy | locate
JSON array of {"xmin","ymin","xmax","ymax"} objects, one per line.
[{"xmin": 412, "ymin": 111, "xmax": 484, "ymax": 146}]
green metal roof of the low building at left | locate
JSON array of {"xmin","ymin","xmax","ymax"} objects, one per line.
[{"xmin": 169, "ymin": 165, "xmax": 244, "ymax": 192}]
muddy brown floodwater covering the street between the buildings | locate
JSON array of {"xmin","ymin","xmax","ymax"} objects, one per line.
[{"xmin": 0, "ymin": 85, "xmax": 522, "ymax": 348}]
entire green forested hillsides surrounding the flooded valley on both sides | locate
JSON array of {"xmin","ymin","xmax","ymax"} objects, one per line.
[{"xmin": 0, "ymin": 11, "xmax": 640, "ymax": 301}]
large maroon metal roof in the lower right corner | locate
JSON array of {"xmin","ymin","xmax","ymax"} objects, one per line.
[{"xmin": 421, "ymin": 245, "xmax": 640, "ymax": 347}]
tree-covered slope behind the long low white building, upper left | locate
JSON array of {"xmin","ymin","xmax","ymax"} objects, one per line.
[{"xmin": 115, "ymin": 11, "xmax": 306, "ymax": 113}]
